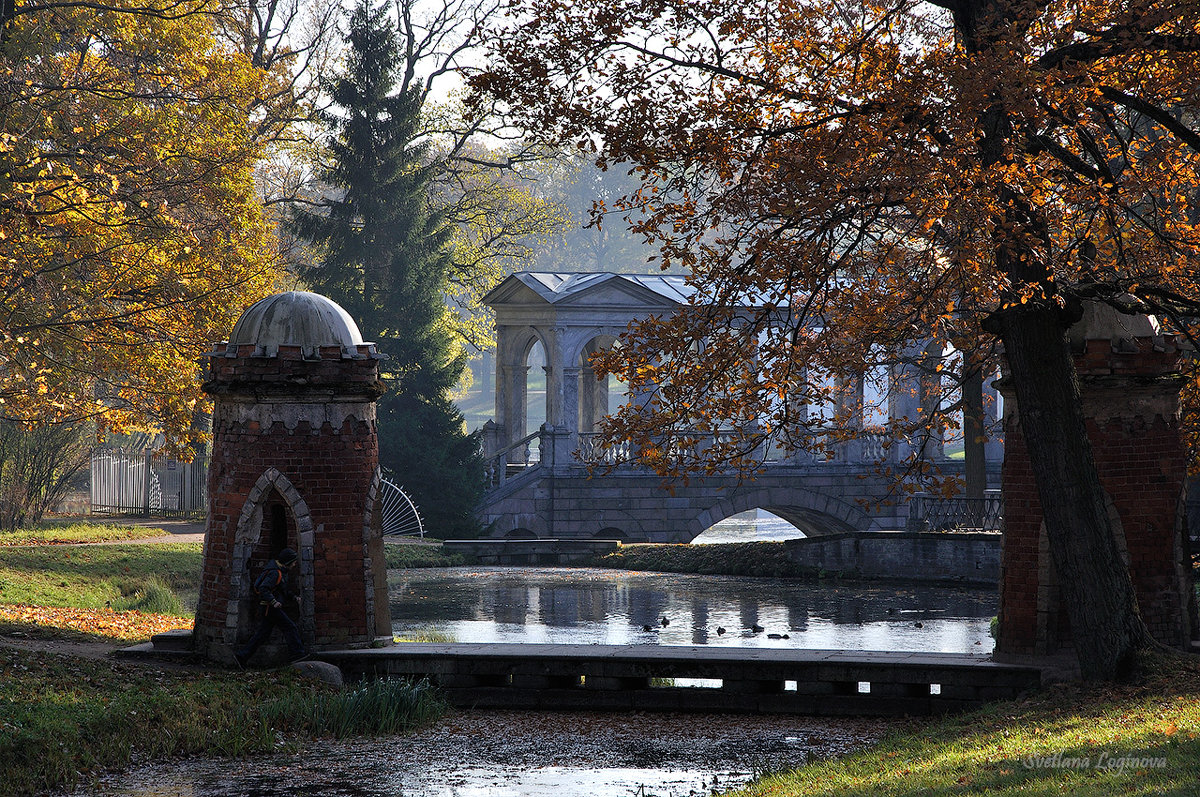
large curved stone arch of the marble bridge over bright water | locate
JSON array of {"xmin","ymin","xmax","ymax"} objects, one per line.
[{"xmin": 686, "ymin": 487, "xmax": 881, "ymax": 541}]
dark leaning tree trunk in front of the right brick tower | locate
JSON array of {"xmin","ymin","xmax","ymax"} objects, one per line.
[{"xmin": 995, "ymin": 302, "xmax": 1152, "ymax": 679}]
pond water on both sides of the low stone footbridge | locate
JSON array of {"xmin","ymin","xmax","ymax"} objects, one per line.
[{"xmin": 74, "ymin": 559, "xmax": 997, "ymax": 797}]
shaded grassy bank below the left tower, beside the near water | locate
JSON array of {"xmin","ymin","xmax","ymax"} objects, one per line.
[{"xmin": 0, "ymin": 648, "xmax": 444, "ymax": 796}]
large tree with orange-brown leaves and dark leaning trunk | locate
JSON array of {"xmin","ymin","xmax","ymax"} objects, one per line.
[{"xmin": 476, "ymin": 0, "xmax": 1200, "ymax": 677}]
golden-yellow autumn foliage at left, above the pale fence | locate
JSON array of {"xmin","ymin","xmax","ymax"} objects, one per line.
[{"xmin": 0, "ymin": 0, "xmax": 274, "ymax": 444}]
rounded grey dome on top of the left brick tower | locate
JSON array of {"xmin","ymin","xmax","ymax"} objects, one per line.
[{"xmin": 229, "ymin": 290, "xmax": 364, "ymax": 356}]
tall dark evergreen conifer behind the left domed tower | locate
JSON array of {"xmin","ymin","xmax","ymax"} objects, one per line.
[{"xmin": 292, "ymin": 0, "xmax": 482, "ymax": 535}]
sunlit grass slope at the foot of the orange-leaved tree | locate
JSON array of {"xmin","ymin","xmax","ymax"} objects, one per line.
[{"xmin": 732, "ymin": 655, "xmax": 1200, "ymax": 797}]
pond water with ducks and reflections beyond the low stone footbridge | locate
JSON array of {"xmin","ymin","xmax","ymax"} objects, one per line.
[{"xmin": 389, "ymin": 568, "xmax": 997, "ymax": 654}]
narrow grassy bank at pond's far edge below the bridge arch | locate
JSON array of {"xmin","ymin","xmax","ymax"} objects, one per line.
[{"xmin": 588, "ymin": 543, "xmax": 815, "ymax": 576}]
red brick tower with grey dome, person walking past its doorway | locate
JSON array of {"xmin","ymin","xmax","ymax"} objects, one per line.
[{"xmin": 193, "ymin": 292, "xmax": 391, "ymax": 661}]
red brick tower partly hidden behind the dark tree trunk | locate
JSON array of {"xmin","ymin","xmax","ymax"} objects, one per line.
[{"xmin": 996, "ymin": 305, "xmax": 1196, "ymax": 655}]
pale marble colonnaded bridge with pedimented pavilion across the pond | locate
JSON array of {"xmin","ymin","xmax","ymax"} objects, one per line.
[{"xmin": 480, "ymin": 272, "xmax": 1003, "ymax": 543}]
